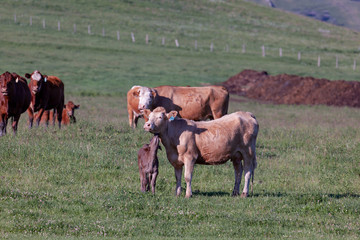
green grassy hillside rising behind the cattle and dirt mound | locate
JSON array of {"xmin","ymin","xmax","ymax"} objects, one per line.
[{"xmin": 0, "ymin": 0, "xmax": 360, "ymax": 96}]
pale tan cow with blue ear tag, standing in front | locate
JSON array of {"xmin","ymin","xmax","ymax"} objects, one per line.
[{"xmin": 144, "ymin": 107, "xmax": 259, "ymax": 198}]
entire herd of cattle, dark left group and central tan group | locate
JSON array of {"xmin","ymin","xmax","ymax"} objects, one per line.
[{"xmin": 0, "ymin": 70, "xmax": 259, "ymax": 198}]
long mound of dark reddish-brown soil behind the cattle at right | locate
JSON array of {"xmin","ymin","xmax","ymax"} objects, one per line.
[{"xmin": 222, "ymin": 70, "xmax": 360, "ymax": 107}]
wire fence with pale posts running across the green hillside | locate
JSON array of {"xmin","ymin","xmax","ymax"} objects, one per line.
[{"xmin": 0, "ymin": 14, "xmax": 359, "ymax": 71}]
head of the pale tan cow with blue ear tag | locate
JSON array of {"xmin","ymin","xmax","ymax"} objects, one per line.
[{"xmin": 144, "ymin": 107, "xmax": 178, "ymax": 134}]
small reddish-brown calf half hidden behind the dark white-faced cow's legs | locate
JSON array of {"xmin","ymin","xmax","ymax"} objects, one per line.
[{"xmin": 40, "ymin": 101, "xmax": 80, "ymax": 125}]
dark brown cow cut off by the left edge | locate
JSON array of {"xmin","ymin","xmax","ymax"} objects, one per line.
[{"xmin": 0, "ymin": 72, "xmax": 31, "ymax": 136}]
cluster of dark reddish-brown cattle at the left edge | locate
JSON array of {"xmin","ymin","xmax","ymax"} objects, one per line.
[{"xmin": 0, "ymin": 70, "xmax": 79, "ymax": 136}]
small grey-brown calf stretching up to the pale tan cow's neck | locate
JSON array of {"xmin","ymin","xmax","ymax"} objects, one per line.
[{"xmin": 138, "ymin": 135, "xmax": 161, "ymax": 194}]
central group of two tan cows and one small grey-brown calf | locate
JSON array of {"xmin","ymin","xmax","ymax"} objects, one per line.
[{"xmin": 127, "ymin": 86, "xmax": 259, "ymax": 198}]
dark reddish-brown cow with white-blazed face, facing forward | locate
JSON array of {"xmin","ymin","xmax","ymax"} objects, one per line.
[{"xmin": 25, "ymin": 70, "xmax": 64, "ymax": 128}]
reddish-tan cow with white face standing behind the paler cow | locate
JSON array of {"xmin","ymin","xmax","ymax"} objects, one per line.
[{"xmin": 127, "ymin": 86, "xmax": 229, "ymax": 128}]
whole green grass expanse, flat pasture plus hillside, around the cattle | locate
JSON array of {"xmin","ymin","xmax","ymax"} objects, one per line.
[{"xmin": 0, "ymin": 0, "xmax": 360, "ymax": 239}]
